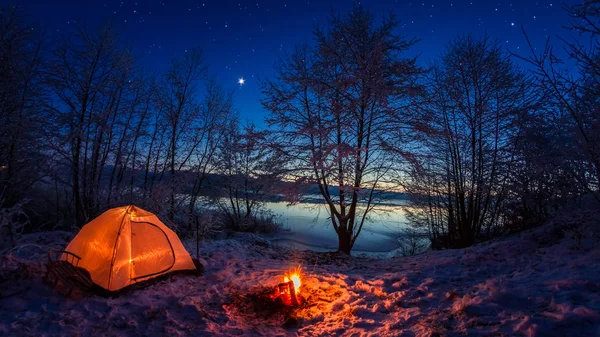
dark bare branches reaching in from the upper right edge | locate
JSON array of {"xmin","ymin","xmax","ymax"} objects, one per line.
[{"xmin": 520, "ymin": 0, "xmax": 600, "ymax": 202}]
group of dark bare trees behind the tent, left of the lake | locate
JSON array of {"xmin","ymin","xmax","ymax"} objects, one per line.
[{"xmin": 0, "ymin": 6, "xmax": 284, "ymax": 247}]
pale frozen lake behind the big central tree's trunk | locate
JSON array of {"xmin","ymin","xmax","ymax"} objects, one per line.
[{"xmin": 265, "ymin": 200, "xmax": 407, "ymax": 253}]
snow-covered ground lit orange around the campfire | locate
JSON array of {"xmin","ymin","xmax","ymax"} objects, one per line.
[{"xmin": 0, "ymin": 217, "xmax": 600, "ymax": 336}]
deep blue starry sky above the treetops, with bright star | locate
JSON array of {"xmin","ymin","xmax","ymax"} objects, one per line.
[{"xmin": 15, "ymin": 0, "xmax": 574, "ymax": 127}]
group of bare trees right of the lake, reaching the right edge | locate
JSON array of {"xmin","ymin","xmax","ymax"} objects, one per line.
[{"xmin": 404, "ymin": 1, "xmax": 600, "ymax": 248}]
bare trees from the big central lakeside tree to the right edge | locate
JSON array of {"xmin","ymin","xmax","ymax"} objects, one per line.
[{"xmin": 263, "ymin": 1, "xmax": 600, "ymax": 254}]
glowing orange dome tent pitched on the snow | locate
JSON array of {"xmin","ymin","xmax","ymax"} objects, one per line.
[{"xmin": 66, "ymin": 206, "xmax": 196, "ymax": 291}]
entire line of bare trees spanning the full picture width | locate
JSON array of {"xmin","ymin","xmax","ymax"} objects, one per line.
[{"xmin": 0, "ymin": 1, "xmax": 600, "ymax": 253}]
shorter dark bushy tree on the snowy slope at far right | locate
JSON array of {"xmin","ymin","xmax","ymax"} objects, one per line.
[{"xmin": 502, "ymin": 103, "xmax": 589, "ymax": 232}]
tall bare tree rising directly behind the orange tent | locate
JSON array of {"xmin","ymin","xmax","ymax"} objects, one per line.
[{"xmin": 48, "ymin": 26, "xmax": 133, "ymax": 227}]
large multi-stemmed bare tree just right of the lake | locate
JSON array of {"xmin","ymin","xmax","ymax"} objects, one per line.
[{"xmin": 404, "ymin": 35, "xmax": 535, "ymax": 247}]
